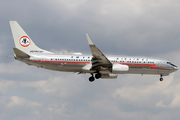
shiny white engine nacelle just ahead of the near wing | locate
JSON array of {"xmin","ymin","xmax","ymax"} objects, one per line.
[{"xmin": 112, "ymin": 64, "xmax": 129, "ymax": 74}]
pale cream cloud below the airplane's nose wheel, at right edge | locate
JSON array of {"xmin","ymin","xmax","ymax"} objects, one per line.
[{"xmin": 113, "ymin": 75, "xmax": 180, "ymax": 108}]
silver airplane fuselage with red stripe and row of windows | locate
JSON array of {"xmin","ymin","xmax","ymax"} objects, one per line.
[{"xmin": 16, "ymin": 55, "xmax": 177, "ymax": 76}]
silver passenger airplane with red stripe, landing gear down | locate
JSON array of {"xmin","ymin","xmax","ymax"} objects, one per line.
[{"xmin": 10, "ymin": 21, "xmax": 178, "ymax": 82}]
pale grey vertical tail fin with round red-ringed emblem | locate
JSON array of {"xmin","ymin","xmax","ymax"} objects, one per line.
[{"xmin": 9, "ymin": 21, "xmax": 52, "ymax": 54}]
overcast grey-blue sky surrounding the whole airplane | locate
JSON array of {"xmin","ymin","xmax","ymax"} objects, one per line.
[{"xmin": 0, "ymin": 0, "xmax": 180, "ymax": 120}]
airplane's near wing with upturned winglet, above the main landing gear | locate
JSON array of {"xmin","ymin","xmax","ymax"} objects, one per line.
[{"xmin": 86, "ymin": 33, "xmax": 112, "ymax": 70}]
